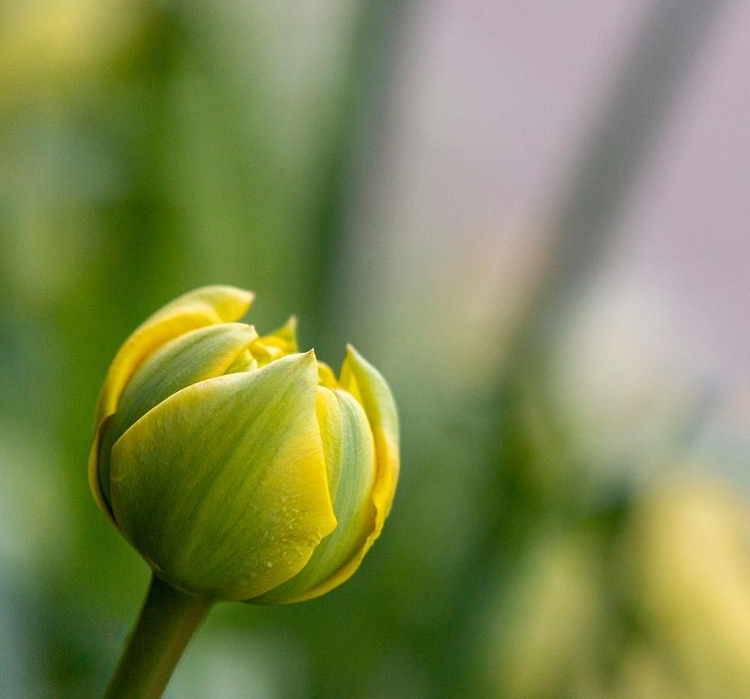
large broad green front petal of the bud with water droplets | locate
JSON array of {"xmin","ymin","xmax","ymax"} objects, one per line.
[{"xmin": 110, "ymin": 353, "xmax": 336, "ymax": 600}]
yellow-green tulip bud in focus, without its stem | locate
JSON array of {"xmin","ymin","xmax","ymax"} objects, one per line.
[{"xmin": 89, "ymin": 286, "xmax": 399, "ymax": 604}]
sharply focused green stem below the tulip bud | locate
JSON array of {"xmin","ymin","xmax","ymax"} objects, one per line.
[{"xmin": 104, "ymin": 575, "xmax": 214, "ymax": 699}]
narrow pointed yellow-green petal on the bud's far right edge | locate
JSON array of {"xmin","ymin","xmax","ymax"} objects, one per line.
[{"xmin": 339, "ymin": 345, "xmax": 399, "ymax": 556}]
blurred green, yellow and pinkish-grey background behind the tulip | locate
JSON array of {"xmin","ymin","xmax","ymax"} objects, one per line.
[{"xmin": 0, "ymin": 0, "xmax": 750, "ymax": 699}]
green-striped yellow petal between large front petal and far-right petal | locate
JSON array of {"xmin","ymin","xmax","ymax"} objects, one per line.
[{"xmin": 250, "ymin": 387, "xmax": 376, "ymax": 604}]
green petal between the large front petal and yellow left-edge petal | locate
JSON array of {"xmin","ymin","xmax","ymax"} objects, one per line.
[{"xmin": 98, "ymin": 323, "xmax": 258, "ymax": 508}]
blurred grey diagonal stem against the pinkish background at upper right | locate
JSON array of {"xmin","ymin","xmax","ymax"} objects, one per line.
[{"xmin": 504, "ymin": 0, "xmax": 727, "ymax": 375}]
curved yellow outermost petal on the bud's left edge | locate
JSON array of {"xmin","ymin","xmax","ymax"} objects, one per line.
[{"xmin": 89, "ymin": 286, "xmax": 254, "ymax": 513}]
